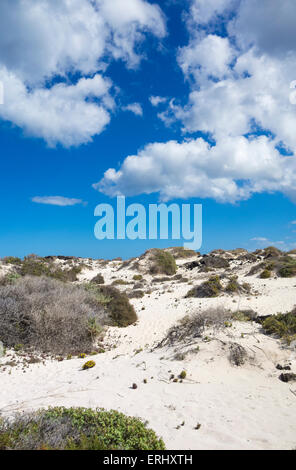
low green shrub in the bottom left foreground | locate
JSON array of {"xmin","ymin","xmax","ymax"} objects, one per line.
[{"xmin": 0, "ymin": 407, "xmax": 165, "ymax": 450}]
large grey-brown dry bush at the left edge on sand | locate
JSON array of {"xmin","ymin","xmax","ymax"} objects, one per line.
[{"xmin": 0, "ymin": 277, "xmax": 108, "ymax": 355}]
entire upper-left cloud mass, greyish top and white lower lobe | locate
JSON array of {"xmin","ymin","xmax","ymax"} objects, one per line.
[{"xmin": 0, "ymin": 0, "xmax": 165, "ymax": 146}]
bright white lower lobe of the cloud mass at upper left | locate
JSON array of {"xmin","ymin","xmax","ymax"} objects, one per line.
[{"xmin": 0, "ymin": 69, "xmax": 113, "ymax": 147}]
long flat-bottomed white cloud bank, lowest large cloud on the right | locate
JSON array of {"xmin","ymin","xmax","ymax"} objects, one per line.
[{"xmin": 93, "ymin": 136, "xmax": 296, "ymax": 203}]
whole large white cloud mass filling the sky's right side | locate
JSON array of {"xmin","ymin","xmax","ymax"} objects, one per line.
[{"xmin": 95, "ymin": 0, "xmax": 296, "ymax": 203}]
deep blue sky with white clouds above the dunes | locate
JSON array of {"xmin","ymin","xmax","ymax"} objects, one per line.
[{"xmin": 0, "ymin": 0, "xmax": 296, "ymax": 258}]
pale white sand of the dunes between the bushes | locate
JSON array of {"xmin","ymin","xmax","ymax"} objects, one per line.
[{"xmin": 0, "ymin": 253, "xmax": 296, "ymax": 450}]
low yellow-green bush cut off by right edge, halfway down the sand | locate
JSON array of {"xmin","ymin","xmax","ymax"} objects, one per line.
[{"xmin": 262, "ymin": 309, "xmax": 296, "ymax": 344}]
